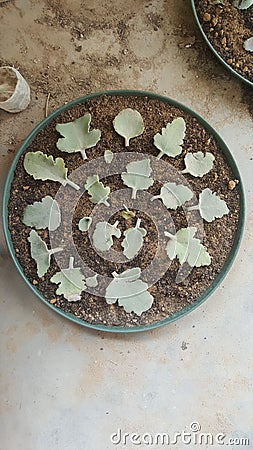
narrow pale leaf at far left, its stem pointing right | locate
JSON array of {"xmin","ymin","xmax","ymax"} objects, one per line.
[{"xmin": 28, "ymin": 230, "xmax": 63, "ymax": 278}]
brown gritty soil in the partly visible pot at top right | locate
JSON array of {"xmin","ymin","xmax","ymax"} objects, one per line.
[{"xmin": 195, "ymin": 0, "xmax": 253, "ymax": 83}]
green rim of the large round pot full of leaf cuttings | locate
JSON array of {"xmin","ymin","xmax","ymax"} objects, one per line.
[{"xmin": 3, "ymin": 90, "xmax": 245, "ymax": 333}]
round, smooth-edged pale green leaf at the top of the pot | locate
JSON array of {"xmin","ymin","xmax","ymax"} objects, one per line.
[{"xmin": 113, "ymin": 108, "xmax": 144, "ymax": 147}]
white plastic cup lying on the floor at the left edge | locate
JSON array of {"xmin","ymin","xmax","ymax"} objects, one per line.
[{"xmin": 0, "ymin": 66, "xmax": 30, "ymax": 113}]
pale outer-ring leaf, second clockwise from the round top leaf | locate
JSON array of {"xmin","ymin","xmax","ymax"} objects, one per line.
[{"xmin": 182, "ymin": 152, "xmax": 215, "ymax": 177}]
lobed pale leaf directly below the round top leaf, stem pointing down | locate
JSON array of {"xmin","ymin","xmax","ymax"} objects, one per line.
[{"xmin": 121, "ymin": 159, "xmax": 154, "ymax": 199}]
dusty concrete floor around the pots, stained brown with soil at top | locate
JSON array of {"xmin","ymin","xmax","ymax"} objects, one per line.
[{"xmin": 0, "ymin": 0, "xmax": 253, "ymax": 450}]
